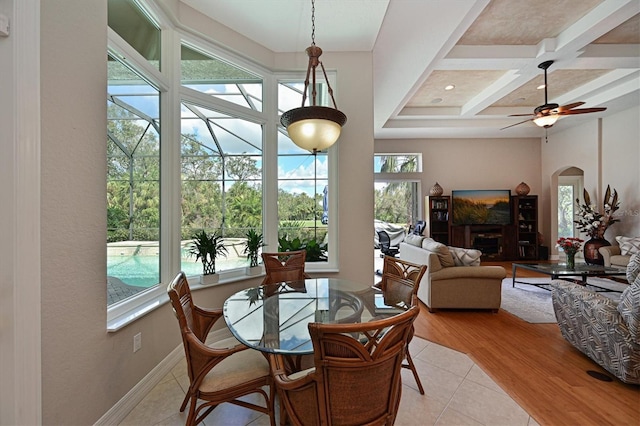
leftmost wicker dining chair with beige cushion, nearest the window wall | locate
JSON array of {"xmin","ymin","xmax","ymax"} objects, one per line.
[{"xmin": 167, "ymin": 272, "xmax": 275, "ymax": 426}]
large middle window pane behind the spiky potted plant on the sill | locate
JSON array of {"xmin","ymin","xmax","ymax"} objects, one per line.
[{"xmin": 181, "ymin": 102, "xmax": 262, "ymax": 274}]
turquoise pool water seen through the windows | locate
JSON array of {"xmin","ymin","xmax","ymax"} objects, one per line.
[{"xmin": 107, "ymin": 256, "xmax": 247, "ymax": 288}]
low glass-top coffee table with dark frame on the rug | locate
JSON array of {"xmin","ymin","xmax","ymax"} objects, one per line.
[{"xmin": 511, "ymin": 263, "xmax": 627, "ymax": 291}]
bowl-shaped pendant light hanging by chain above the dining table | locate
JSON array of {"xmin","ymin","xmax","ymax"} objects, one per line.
[{"xmin": 280, "ymin": 0, "xmax": 347, "ymax": 154}]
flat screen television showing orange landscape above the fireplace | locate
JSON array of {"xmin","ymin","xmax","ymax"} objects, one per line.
[{"xmin": 451, "ymin": 189, "xmax": 511, "ymax": 225}]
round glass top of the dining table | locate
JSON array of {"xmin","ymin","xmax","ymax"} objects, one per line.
[{"xmin": 223, "ymin": 278, "xmax": 408, "ymax": 355}]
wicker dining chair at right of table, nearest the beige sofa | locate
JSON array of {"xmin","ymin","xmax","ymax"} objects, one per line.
[{"xmin": 377, "ymin": 256, "xmax": 427, "ymax": 395}]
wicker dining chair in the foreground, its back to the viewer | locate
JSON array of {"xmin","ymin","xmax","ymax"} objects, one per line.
[{"xmin": 269, "ymin": 306, "xmax": 420, "ymax": 425}]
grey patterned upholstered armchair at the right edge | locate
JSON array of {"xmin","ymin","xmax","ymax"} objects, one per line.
[{"xmin": 551, "ymin": 253, "xmax": 640, "ymax": 384}]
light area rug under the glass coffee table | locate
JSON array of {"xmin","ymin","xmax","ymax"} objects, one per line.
[{"xmin": 500, "ymin": 277, "xmax": 627, "ymax": 324}]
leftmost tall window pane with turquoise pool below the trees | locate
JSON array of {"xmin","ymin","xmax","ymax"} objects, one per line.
[{"xmin": 107, "ymin": 55, "xmax": 160, "ymax": 305}]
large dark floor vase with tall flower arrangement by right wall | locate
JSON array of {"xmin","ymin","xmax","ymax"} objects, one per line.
[{"xmin": 574, "ymin": 185, "xmax": 620, "ymax": 265}]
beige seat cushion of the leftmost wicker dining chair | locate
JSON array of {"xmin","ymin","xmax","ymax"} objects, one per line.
[{"xmin": 200, "ymin": 349, "xmax": 269, "ymax": 392}]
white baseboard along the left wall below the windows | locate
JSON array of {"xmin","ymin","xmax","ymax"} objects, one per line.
[{"xmin": 94, "ymin": 329, "xmax": 231, "ymax": 426}]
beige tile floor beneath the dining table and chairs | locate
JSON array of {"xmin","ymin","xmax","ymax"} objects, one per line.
[{"xmin": 120, "ymin": 338, "xmax": 538, "ymax": 426}]
